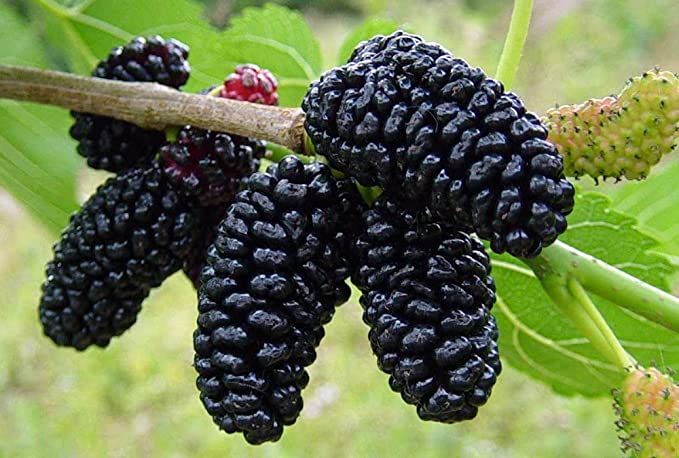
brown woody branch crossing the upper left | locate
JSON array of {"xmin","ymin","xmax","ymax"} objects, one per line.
[{"xmin": 0, "ymin": 65, "xmax": 306, "ymax": 153}]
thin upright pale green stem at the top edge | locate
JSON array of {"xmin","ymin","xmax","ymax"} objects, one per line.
[{"xmin": 495, "ymin": 0, "xmax": 533, "ymax": 88}]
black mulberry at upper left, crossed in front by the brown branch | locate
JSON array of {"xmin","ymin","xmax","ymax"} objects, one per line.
[{"xmin": 70, "ymin": 36, "xmax": 190, "ymax": 172}]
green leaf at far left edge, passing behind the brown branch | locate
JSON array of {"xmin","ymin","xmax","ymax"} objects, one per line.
[{"xmin": 0, "ymin": 3, "xmax": 78, "ymax": 233}]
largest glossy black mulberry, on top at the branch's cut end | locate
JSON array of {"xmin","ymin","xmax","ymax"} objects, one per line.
[{"xmin": 302, "ymin": 32, "xmax": 574, "ymax": 257}]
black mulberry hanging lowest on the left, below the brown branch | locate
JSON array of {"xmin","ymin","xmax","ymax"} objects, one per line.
[{"xmin": 39, "ymin": 163, "xmax": 198, "ymax": 350}]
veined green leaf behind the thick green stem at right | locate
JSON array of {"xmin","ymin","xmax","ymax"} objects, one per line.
[{"xmin": 493, "ymin": 193, "xmax": 679, "ymax": 396}]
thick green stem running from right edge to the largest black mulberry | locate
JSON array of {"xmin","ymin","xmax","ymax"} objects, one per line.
[{"xmin": 525, "ymin": 242, "xmax": 679, "ymax": 332}]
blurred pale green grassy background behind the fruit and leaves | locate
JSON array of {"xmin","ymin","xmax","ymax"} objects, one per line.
[{"xmin": 0, "ymin": 0, "xmax": 679, "ymax": 457}]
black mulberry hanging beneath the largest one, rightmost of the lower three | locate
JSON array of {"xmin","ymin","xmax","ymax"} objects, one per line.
[{"xmin": 352, "ymin": 194, "xmax": 502, "ymax": 423}]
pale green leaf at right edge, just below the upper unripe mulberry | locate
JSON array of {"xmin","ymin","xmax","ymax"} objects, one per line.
[{"xmin": 611, "ymin": 160, "xmax": 679, "ymax": 256}]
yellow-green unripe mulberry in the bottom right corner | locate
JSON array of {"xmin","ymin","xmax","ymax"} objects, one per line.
[{"xmin": 614, "ymin": 368, "xmax": 679, "ymax": 458}]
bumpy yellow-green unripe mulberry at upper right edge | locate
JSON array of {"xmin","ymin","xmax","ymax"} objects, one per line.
[{"xmin": 545, "ymin": 70, "xmax": 679, "ymax": 180}]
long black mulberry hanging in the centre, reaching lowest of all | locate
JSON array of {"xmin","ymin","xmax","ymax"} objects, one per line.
[{"xmin": 194, "ymin": 157, "xmax": 362, "ymax": 444}]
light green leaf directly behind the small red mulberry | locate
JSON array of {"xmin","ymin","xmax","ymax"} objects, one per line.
[{"xmin": 211, "ymin": 4, "xmax": 322, "ymax": 106}]
